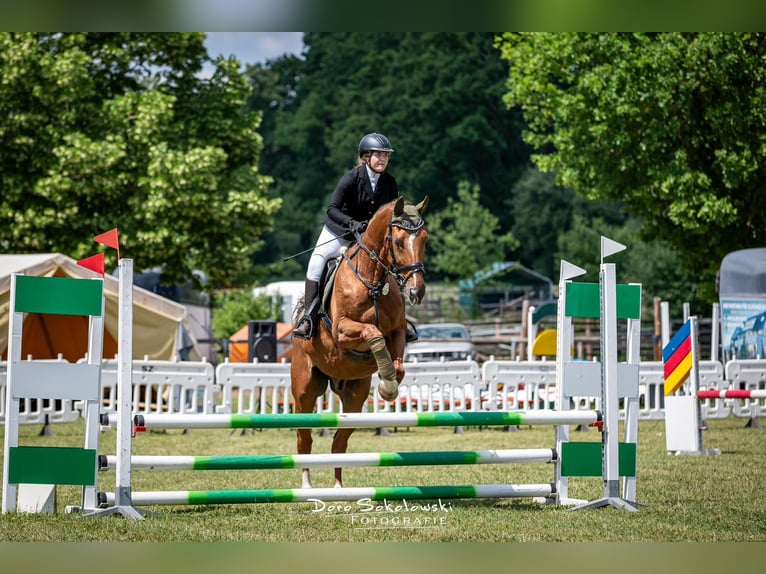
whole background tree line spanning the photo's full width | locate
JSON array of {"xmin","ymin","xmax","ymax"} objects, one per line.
[{"xmin": 7, "ymin": 32, "xmax": 766, "ymax": 316}]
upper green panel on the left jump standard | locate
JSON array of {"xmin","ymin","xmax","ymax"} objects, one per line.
[{"xmin": 13, "ymin": 275, "xmax": 104, "ymax": 317}]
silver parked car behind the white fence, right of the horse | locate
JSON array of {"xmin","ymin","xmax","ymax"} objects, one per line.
[{"xmin": 404, "ymin": 323, "xmax": 478, "ymax": 362}]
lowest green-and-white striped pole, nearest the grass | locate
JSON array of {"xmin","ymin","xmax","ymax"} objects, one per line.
[{"xmin": 99, "ymin": 484, "xmax": 555, "ymax": 506}]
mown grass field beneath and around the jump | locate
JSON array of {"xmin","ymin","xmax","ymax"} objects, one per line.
[{"xmin": 0, "ymin": 418, "xmax": 766, "ymax": 542}]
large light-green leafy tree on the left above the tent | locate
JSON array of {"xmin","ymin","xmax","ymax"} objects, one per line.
[{"xmin": 0, "ymin": 32, "xmax": 279, "ymax": 287}]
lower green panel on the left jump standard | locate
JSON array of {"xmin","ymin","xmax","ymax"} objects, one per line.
[{"xmin": 8, "ymin": 446, "xmax": 96, "ymax": 486}]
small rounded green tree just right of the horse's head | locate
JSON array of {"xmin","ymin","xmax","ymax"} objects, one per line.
[{"xmin": 428, "ymin": 182, "xmax": 518, "ymax": 279}]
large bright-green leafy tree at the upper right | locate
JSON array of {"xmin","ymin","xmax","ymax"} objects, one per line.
[{"xmin": 498, "ymin": 33, "xmax": 766, "ymax": 300}]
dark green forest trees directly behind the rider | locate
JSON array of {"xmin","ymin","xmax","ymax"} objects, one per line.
[{"xmin": 255, "ymin": 32, "xmax": 529, "ymax": 273}]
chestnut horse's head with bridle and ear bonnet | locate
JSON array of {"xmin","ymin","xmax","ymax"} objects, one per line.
[{"xmin": 387, "ymin": 196, "xmax": 429, "ymax": 305}]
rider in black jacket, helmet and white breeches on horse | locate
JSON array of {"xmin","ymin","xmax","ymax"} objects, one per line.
[{"xmin": 293, "ymin": 132, "xmax": 399, "ymax": 339}]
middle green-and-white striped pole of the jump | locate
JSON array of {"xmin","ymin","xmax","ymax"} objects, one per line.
[{"xmin": 99, "ymin": 448, "xmax": 557, "ymax": 470}]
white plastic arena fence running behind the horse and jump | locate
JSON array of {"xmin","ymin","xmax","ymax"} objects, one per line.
[{"xmin": 0, "ymin": 358, "xmax": 766, "ymax": 424}]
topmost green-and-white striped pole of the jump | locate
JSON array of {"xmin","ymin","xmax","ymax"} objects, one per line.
[{"xmin": 133, "ymin": 410, "xmax": 601, "ymax": 430}]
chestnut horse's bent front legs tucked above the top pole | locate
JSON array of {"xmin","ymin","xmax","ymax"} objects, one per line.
[{"xmin": 336, "ymin": 318, "xmax": 406, "ymax": 402}]
